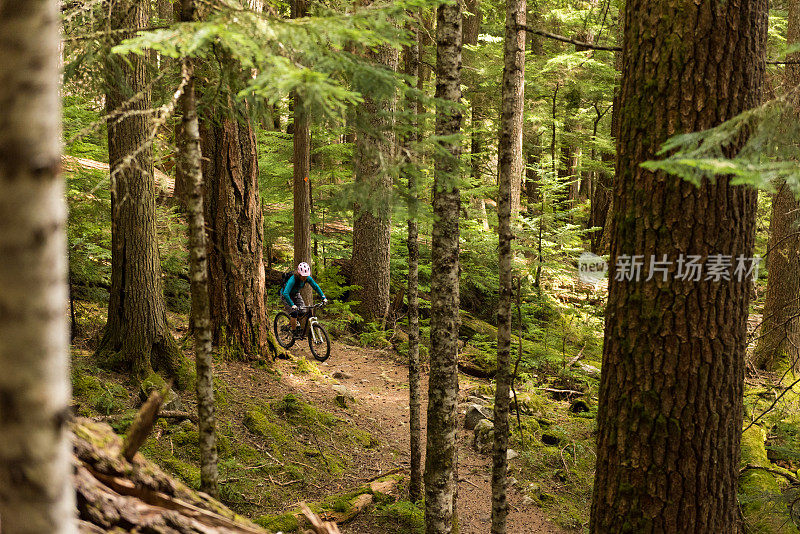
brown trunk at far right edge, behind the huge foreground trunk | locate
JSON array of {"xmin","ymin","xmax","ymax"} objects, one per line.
[{"xmin": 753, "ymin": 0, "xmax": 800, "ymax": 370}]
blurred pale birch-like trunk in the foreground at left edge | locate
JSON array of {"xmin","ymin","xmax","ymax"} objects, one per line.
[{"xmin": 0, "ymin": 0, "xmax": 76, "ymax": 534}]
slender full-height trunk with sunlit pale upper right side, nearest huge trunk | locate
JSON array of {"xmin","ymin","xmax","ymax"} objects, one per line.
[{"xmin": 492, "ymin": 0, "xmax": 527, "ymax": 534}]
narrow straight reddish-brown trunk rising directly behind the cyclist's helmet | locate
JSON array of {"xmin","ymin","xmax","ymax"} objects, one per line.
[{"xmin": 292, "ymin": 0, "xmax": 313, "ymax": 305}]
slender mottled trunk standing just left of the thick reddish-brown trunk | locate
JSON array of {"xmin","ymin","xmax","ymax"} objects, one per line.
[{"xmin": 179, "ymin": 0, "xmax": 219, "ymax": 497}]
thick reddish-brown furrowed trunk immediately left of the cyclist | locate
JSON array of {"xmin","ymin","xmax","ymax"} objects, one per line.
[{"xmin": 200, "ymin": 99, "xmax": 267, "ymax": 358}]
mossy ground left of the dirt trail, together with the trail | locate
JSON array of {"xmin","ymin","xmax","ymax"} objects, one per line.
[{"xmin": 72, "ymin": 302, "xmax": 577, "ymax": 534}]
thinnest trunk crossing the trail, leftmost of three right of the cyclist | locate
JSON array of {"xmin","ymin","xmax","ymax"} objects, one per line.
[{"xmin": 401, "ymin": 23, "xmax": 422, "ymax": 502}]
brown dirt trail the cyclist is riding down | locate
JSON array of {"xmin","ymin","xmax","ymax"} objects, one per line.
[{"xmin": 278, "ymin": 343, "xmax": 565, "ymax": 534}]
